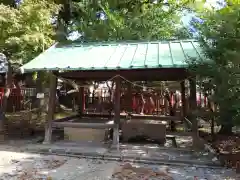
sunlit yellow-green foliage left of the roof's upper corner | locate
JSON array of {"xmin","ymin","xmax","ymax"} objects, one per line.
[{"xmin": 0, "ymin": 0, "xmax": 58, "ymax": 64}]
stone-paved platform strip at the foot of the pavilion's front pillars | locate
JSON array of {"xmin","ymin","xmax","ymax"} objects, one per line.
[{"xmin": 24, "ymin": 142, "xmax": 219, "ymax": 165}]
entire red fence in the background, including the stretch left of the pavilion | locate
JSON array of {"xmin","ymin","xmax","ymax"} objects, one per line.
[{"xmin": 0, "ymin": 88, "xmax": 207, "ymax": 114}]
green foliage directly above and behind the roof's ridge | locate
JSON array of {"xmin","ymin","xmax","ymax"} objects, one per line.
[{"xmin": 70, "ymin": 0, "xmax": 195, "ymax": 41}]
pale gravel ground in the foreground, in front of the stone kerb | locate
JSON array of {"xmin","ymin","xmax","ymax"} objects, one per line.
[{"xmin": 0, "ymin": 151, "xmax": 240, "ymax": 180}]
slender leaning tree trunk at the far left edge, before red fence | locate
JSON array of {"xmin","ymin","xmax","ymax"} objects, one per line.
[{"xmin": 0, "ymin": 63, "xmax": 13, "ymax": 138}]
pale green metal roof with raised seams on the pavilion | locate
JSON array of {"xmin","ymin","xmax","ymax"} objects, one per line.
[{"xmin": 21, "ymin": 40, "xmax": 201, "ymax": 72}]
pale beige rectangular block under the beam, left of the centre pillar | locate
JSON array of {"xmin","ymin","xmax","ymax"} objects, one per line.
[{"xmin": 64, "ymin": 127, "xmax": 106, "ymax": 142}]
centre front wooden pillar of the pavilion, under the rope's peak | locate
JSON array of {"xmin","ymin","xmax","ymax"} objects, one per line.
[{"xmin": 113, "ymin": 77, "xmax": 121, "ymax": 147}]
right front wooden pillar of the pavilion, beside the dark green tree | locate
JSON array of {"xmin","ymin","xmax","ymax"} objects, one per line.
[{"xmin": 189, "ymin": 78, "xmax": 199, "ymax": 148}]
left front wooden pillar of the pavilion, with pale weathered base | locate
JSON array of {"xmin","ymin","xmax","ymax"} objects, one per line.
[{"xmin": 43, "ymin": 73, "xmax": 57, "ymax": 144}]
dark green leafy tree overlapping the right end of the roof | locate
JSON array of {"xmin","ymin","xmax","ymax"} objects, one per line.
[{"xmin": 192, "ymin": 4, "xmax": 240, "ymax": 125}]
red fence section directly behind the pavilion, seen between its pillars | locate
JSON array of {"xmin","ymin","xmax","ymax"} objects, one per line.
[{"xmin": 84, "ymin": 94, "xmax": 207, "ymax": 114}]
